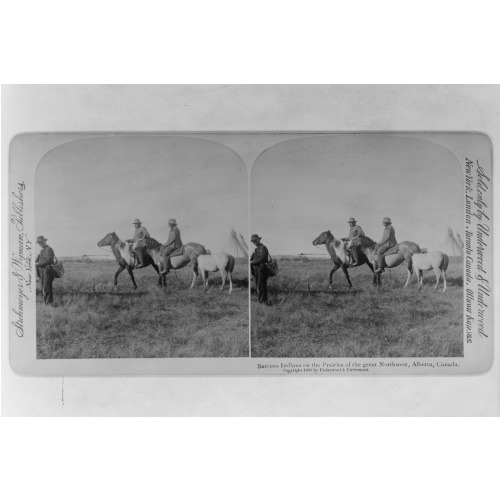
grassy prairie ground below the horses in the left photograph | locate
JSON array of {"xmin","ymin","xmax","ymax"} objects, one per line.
[{"xmin": 37, "ymin": 259, "xmax": 249, "ymax": 359}]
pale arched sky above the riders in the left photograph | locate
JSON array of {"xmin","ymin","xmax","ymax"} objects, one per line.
[{"xmin": 35, "ymin": 136, "xmax": 248, "ymax": 256}]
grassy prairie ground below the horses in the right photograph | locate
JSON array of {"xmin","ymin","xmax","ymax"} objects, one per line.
[{"xmin": 251, "ymin": 258, "xmax": 463, "ymax": 358}]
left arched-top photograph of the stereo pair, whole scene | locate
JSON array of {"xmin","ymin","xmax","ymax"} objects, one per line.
[{"xmin": 34, "ymin": 134, "xmax": 249, "ymax": 359}]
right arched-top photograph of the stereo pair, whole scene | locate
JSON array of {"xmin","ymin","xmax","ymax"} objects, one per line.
[{"xmin": 250, "ymin": 133, "xmax": 465, "ymax": 358}]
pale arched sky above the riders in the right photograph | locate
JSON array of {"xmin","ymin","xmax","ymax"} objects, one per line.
[{"xmin": 250, "ymin": 134, "xmax": 464, "ymax": 255}]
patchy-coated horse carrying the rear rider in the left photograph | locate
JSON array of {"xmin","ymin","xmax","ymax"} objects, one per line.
[{"xmin": 132, "ymin": 236, "xmax": 207, "ymax": 288}]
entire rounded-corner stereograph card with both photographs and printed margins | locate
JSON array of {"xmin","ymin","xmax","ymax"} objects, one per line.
[{"xmin": 8, "ymin": 129, "xmax": 494, "ymax": 377}]
